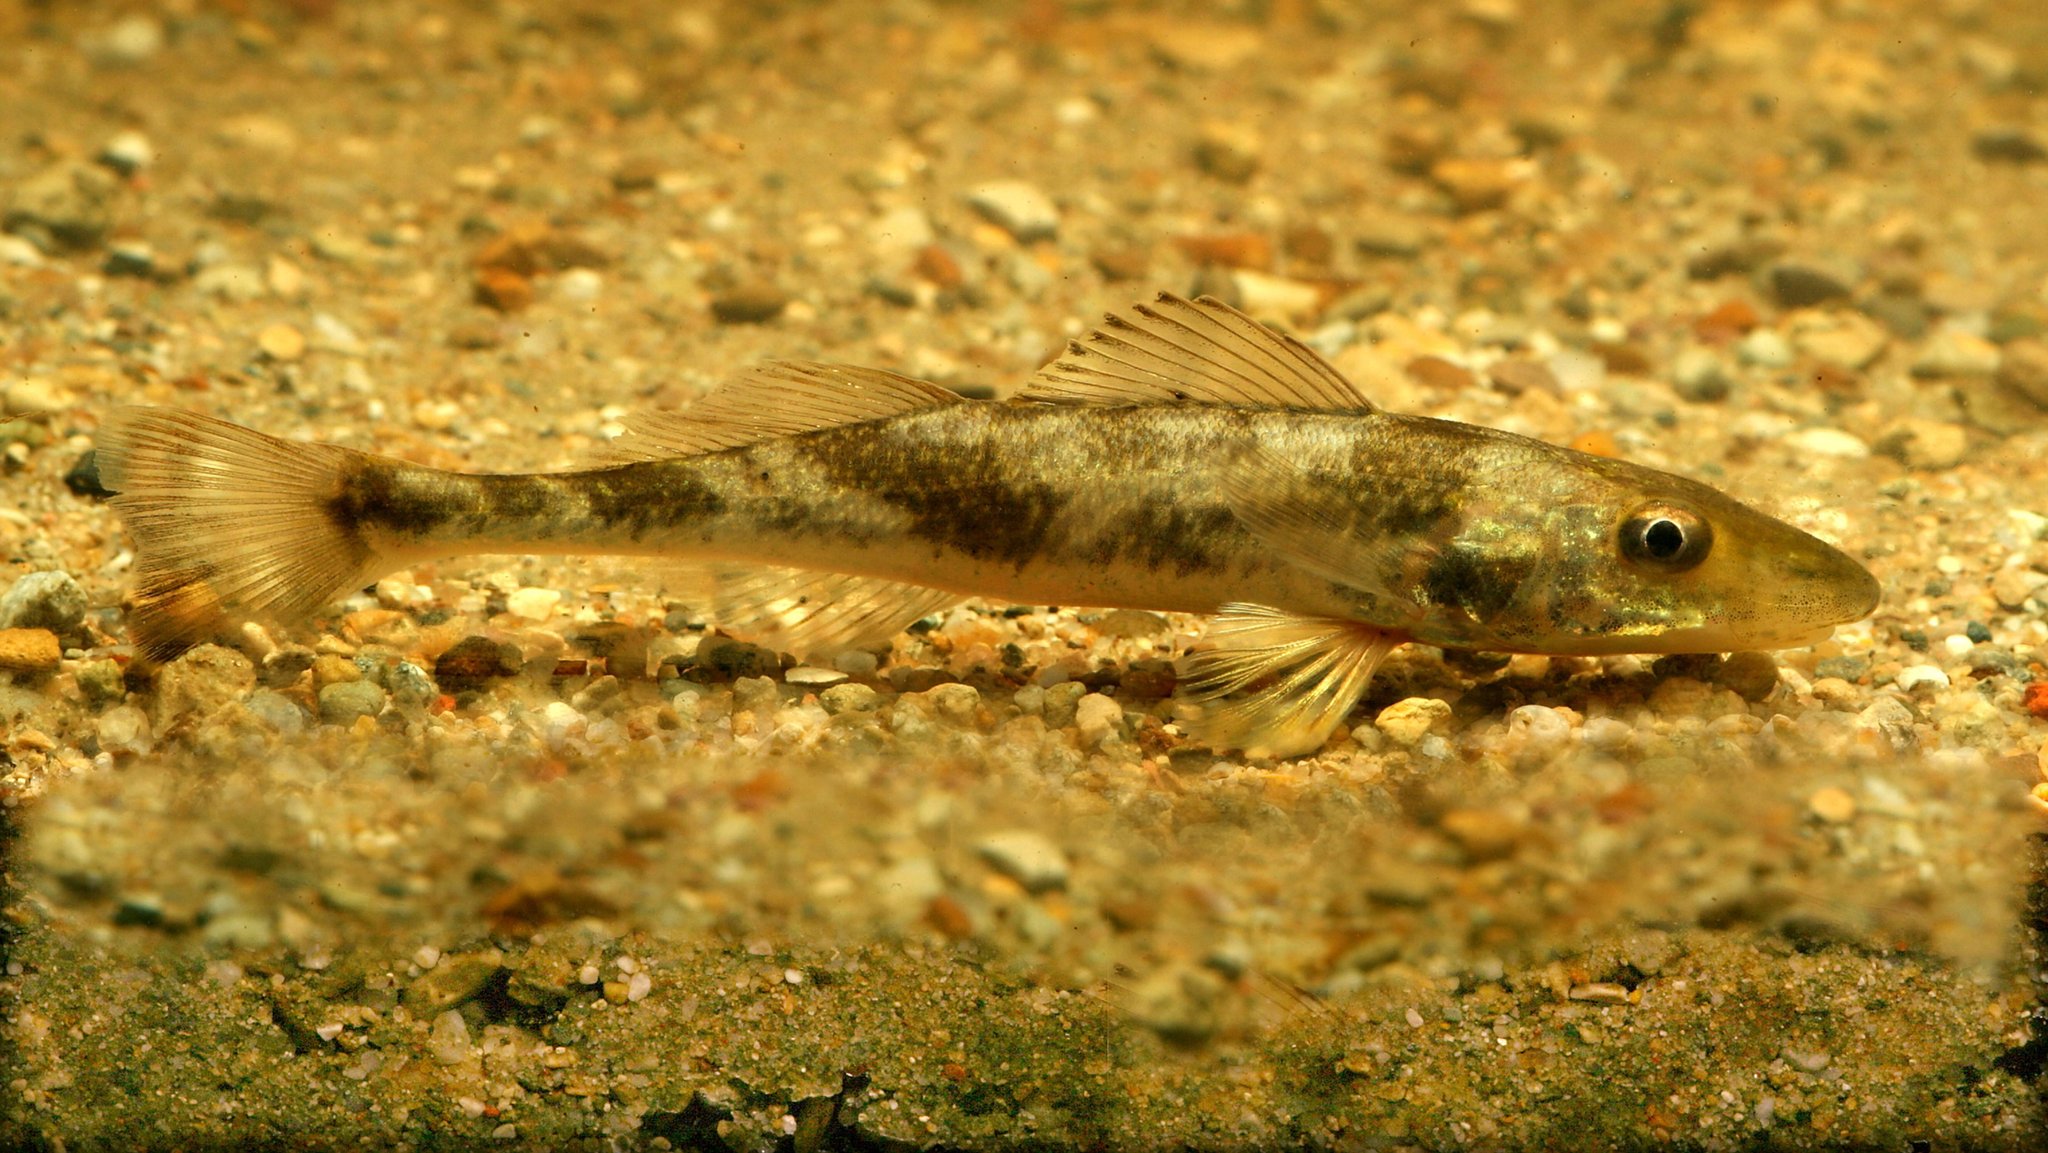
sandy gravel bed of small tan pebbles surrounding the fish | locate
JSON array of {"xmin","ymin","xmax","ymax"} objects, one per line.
[{"xmin": 0, "ymin": 0, "xmax": 2048, "ymax": 1151}]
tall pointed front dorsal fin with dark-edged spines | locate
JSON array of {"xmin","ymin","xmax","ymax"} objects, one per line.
[{"xmin": 1018, "ymin": 293, "xmax": 1376, "ymax": 412}]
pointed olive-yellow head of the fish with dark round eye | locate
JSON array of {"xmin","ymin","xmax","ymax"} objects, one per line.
[{"xmin": 1409, "ymin": 449, "xmax": 1878, "ymax": 655}]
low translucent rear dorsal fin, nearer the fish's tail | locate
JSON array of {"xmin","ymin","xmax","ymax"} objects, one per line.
[{"xmin": 604, "ymin": 360, "xmax": 963, "ymax": 465}]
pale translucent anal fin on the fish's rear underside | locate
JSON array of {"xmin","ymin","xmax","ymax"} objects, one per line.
[{"xmin": 671, "ymin": 565, "xmax": 963, "ymax": 655}]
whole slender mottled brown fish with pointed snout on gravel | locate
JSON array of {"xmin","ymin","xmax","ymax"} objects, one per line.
[{"xmin": 96, "ymin": 293, "xmax": 1880, "ymax": 758}]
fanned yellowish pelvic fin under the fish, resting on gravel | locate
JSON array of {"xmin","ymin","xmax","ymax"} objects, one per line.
[{"xmin": 1184, "ymin": 604, "xmax": 1403, "ymax": 756}]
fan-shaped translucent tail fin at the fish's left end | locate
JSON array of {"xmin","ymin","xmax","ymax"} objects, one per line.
[{"xmin": 96, "ymin": 408, "xmax": 379, "ymax": 659}]
